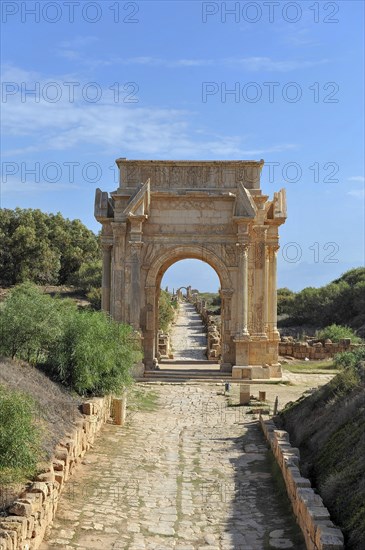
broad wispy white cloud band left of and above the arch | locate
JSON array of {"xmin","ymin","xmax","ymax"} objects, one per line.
[{"xmin": 3, "ymin": 68, "xmax": 296, "ymax": 159}]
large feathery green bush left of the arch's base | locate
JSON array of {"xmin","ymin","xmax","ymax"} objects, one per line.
[{"xmin": 0, "ymin": 283, "xmax": 141, "ymax": 395}]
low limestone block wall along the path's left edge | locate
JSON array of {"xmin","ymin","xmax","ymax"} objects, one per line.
[{"xmin": 0, "ymin": 397, "xmax": 111, "ymax": 550}]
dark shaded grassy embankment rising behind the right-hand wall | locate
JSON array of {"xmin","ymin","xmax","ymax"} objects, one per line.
[{"xmin": 277, "ymin": 360, "xmax": 365, "ymax": 550}]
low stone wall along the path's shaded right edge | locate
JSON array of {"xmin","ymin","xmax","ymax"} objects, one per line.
[{"xmin": 260, "ymin": 416, "xmax": 344, "ymax": 550}]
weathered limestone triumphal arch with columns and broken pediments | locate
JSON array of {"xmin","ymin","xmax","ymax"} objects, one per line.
[{"xmin": 95, "ymin": 158, "xmax": 286, "ymax": 378}]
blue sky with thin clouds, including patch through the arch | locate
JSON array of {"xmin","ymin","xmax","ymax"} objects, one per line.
[{"xmin": 1, "ymin": 0, "xmax": 364, "ymax": 290}]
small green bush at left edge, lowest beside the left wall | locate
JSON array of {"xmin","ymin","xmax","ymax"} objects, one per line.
[{"xmin": 0, "ymin": 386, "xmax": 43, "ymax": 485}]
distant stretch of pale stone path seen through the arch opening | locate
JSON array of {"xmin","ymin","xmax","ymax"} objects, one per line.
[{"xmin": 171, "ymin": 302, "xmax": 207, "ymax": 361}]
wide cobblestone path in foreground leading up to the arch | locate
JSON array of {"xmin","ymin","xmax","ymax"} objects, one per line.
[{"xmin": 41, "ymin": 384, "xmax": 305, "ymax": 550}]
